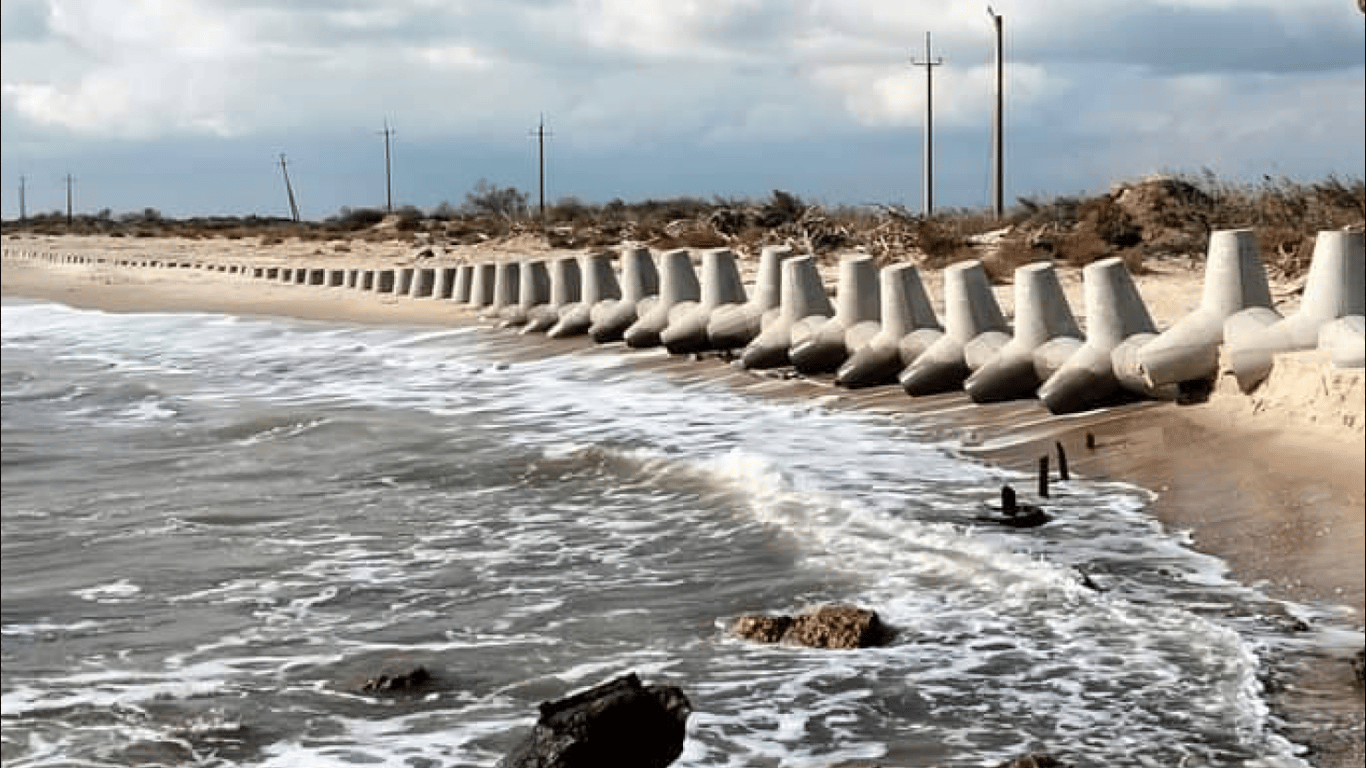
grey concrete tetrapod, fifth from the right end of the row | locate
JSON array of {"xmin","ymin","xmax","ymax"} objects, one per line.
[{"xmin": 897, "ymin": 260, "xmax": 1009, "ymax": 396}]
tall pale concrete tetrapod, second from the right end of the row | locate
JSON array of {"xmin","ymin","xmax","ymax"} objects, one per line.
[{"xmin": 1135, "ymin": 230, "xmax": 1272, "ymax": 387}]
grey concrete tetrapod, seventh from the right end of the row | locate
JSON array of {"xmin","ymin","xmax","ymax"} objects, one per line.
[{"xmin": 788, "ymin": 254, "xmax": 881, "ymax": 374}]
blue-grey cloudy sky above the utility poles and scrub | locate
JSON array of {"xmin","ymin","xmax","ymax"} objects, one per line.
[{"xmin": 0, "ymin": 0, "xmax": 1366, "ymax": 219}]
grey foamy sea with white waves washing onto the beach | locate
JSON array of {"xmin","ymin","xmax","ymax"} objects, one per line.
[{"xmin": 0, "ymin": 298, "xmax": 1362, "ymax": 768}]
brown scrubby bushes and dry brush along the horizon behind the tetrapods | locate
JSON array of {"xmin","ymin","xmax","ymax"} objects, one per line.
[{"xmin": 4, "ymin": 171, "xmax": 1366, "ymax": 279}]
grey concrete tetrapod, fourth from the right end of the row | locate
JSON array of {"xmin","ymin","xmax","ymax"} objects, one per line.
[{"xmin": 963, "ymin": 262, "xmax": 1082, "ymax": 403}]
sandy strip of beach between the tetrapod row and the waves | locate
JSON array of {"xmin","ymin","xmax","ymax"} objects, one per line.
[{"xmin": 3, "ymin": 236, "xmax": 1366, "ymax": 767}]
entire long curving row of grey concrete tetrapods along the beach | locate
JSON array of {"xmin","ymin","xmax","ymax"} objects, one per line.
[{"xmin": 5, "ymin": 230, "xmax": 1366, "ymax": 413}]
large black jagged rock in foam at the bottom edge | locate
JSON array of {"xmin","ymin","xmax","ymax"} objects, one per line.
[{"xmin": 499, "ymin": 674, "xmax": 693, "ymax": 768}]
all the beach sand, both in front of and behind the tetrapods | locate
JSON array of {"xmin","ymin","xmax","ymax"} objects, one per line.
[{"xmin": 3, "ymin": 235, "xmax": 1366, "ymax": 767}]
